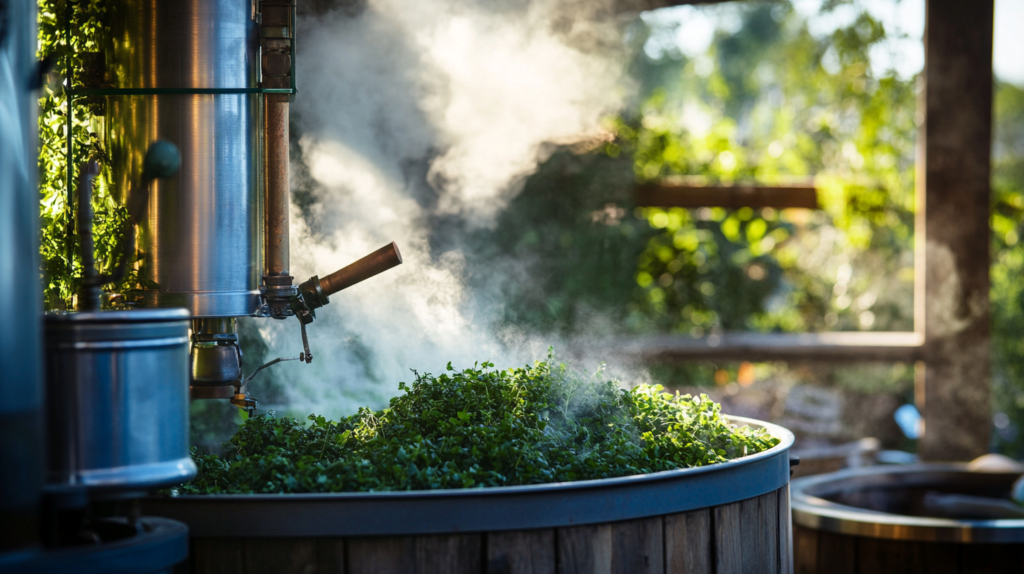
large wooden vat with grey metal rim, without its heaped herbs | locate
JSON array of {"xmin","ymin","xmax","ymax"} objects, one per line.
[{"xmin": 143, "ymin": 418, "xmax": 793, "ymax": 574}]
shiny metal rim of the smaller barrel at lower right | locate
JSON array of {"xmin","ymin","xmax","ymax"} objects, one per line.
[{"xmin": 790, "ymin": 463, "xmax": 1024, "ymax": 543}]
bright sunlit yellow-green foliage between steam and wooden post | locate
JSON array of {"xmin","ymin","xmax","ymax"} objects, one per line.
[{"xmin": 608, "ymin": 3, "xmax": 915, "ymax": 335}]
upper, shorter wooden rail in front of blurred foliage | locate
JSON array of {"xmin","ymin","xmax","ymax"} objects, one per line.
[{"xmin": 633, "ymin": 183, "xmax": 818, "ymax": 210}]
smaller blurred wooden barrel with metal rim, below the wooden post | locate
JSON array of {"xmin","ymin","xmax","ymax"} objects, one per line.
[{"xmin": 793, "ymin": 465, "xmax": 1024, "ymax": 574}]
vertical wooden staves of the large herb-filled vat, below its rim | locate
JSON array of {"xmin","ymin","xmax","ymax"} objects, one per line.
[{"xmin": 190, "ymin": 486, "xmax": 800, "ymax": 574}]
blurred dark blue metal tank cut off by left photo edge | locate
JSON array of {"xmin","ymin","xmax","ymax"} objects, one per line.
[{"xmin": 0, "ymin": 0, "xmax": 45, "ymax": 555}]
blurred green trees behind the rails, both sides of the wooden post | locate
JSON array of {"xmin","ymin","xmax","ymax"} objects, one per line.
[{"xmin": 468, "ymin": 1, "xmax": 1024, "ymax": 456}]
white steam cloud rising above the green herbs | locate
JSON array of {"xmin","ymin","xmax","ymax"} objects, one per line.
[{"xmin": 254, "ymin": 0, "xmax": 625, "ymax": 415}]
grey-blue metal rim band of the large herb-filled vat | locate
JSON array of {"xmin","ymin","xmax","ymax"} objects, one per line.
[{"xmin": 142, "ymin": 416, "xmax": 794, "ymax": 537}]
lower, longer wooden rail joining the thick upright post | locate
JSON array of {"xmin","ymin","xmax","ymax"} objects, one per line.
[{"xmin": 610, "ymin": 332, "xmax": 924, "ymax": 363}]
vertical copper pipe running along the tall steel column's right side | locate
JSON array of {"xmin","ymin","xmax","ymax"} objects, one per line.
[{"xmin": 263, "ymin": 94, "xmax": 291, "ymax": 276}]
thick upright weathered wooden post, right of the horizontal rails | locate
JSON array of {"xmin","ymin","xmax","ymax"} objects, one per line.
[{"xmin": 914, "ymin": 0, "xmax": 993, "ymax": 460}]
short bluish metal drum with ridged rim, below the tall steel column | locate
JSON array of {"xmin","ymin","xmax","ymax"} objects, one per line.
[{"xmin": 46, "ymin": 309, "xmax": 196, "ymax": 491}]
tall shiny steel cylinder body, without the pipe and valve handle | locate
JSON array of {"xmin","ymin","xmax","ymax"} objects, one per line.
[{"xmin": 105, "ymin": 0, "xmax": 263, "ymax": 317}]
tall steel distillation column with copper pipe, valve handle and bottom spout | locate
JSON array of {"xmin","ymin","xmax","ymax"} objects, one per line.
[{"xmin": 101, "ymin": 0, "xmax": 401, "ymax": 409}]
